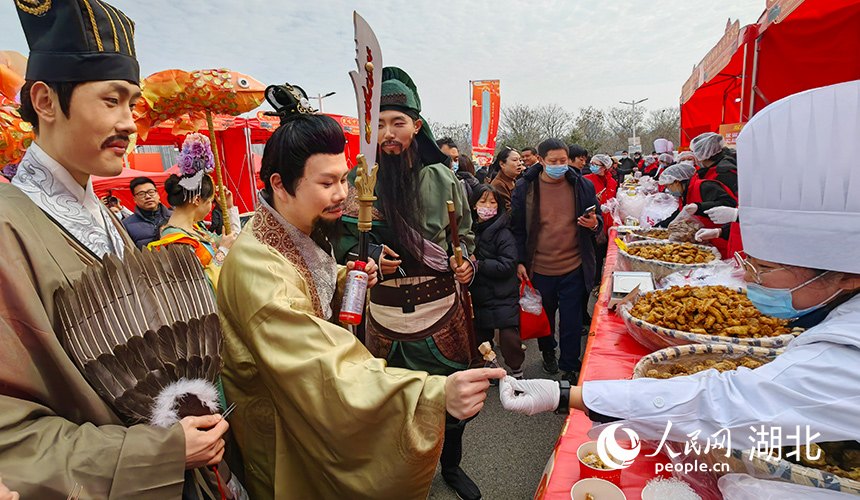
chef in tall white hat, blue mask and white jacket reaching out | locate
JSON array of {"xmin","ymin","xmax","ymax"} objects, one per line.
[{"xmin": 500, "ymin": 81, "xmax": 860, "ymax": 449}]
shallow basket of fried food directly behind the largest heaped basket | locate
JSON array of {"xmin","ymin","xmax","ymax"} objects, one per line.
[{"xmin": 618, "ymin": 240, "xmax": 720, "ymax": 281}]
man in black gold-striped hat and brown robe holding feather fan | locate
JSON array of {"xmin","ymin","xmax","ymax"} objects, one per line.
[{"xmin": 0, "ymin": 0, "xmax": 227, "ymax": 500}]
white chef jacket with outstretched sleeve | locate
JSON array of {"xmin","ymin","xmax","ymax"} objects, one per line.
[{"xmin": 582, "ymin": 295, "xmax": 860, "ymax": 449}]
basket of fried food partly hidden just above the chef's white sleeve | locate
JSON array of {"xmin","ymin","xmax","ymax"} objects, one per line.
[{"xmin": 633, "ymin": 344, "xmax": 782, "ymax": 379}]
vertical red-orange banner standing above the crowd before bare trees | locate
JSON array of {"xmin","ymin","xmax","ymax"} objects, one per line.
[{"xmin": 469, "ymin": 80, "xmax": 501, "ymax": 167}]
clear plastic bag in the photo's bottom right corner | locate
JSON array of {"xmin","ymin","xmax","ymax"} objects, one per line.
[{"xmin": 717, "ymin": 474, "xmax": 857, "ymax": 500}]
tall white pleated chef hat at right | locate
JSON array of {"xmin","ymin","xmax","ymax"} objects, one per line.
[{"xmin": 737, "ymin": 80, "xmax": 860, "ymax": 273}]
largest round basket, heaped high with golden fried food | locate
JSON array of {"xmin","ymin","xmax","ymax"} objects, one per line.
[{"xmin": 621, "ymin": 285, "xmax": 802, "ymax": 350}]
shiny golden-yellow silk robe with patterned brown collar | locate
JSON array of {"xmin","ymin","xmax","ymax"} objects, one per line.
[{"xmin": 218, "ymin": 204, "xmax": 445, "ymax": 500}]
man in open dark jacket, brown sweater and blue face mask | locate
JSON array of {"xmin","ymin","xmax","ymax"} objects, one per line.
[{"xmin": 511, "ymin": 139, "xmax": 603, "ymax": 383}]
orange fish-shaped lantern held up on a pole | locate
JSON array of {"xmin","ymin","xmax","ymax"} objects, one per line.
[{"xmin": 134, "ymin": 69, "xmax": 266, "ymax": 234}]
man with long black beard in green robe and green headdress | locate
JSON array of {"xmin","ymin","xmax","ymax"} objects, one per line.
[{"xmin": 339, "ymin": 67, "xmax": 488, "ymax": 500}]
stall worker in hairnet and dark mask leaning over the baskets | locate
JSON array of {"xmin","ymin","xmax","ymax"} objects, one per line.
[{"xmin": 657, "ymin": 162, "xmax": 738, "ymax": 259}]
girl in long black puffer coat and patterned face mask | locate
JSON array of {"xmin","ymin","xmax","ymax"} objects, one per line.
[{"xmin": 469, "ymin": 184, "xmax": 525, "ymax": 378}]
